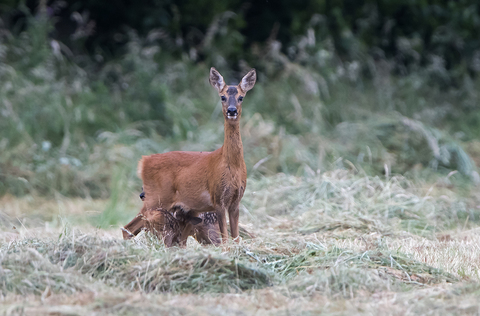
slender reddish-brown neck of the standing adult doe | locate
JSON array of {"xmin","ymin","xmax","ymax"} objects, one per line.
[{"xmin": 223, "ymin": 120, "xmax": 245, "ymax": 167}]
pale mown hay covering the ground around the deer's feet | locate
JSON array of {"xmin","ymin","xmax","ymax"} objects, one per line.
[{"xmin": 0, "ymin": 170, "xmax": 480, "ymax": 315}]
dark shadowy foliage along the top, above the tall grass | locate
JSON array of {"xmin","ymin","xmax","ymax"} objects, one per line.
[{"xmin": 4, "ymin": 0, "xmax": 480, "ymax": 74}]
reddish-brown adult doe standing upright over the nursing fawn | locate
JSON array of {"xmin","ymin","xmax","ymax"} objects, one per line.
[{"xmin": 126, "ymin": 67, "xmax": 257, "ymax": 242}]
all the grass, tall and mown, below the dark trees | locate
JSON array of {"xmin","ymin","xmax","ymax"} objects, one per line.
[{"xmin": 0, "ymin": 18, "xmax": 480, "ymax": 315}]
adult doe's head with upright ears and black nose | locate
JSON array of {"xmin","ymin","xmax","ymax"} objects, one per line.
[{"xmin": 210, "ymin": 67, "xmax": 257, "ymax": 123}]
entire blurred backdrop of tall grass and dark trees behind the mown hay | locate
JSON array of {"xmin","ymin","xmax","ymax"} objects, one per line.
[{"xmin": 0, "ymin": 0, "xmax": 480, "ymax": 200}]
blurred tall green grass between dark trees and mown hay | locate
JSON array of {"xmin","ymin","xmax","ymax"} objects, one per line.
[{"xmin": 0, "ymin": 7, "xmax": 480, "ymax": 198}]
